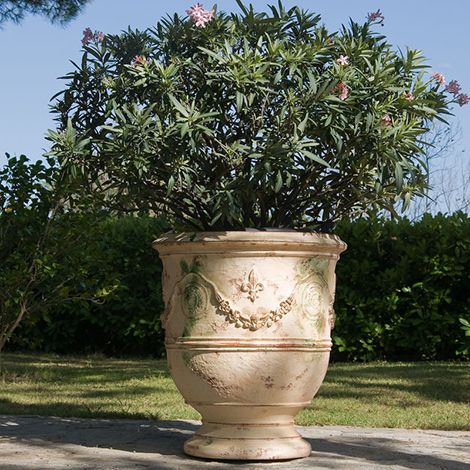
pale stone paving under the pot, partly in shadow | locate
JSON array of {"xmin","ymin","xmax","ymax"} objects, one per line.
[{"xmin": 0, "ymin": 415, "xmax": 470, "ymax": 470}]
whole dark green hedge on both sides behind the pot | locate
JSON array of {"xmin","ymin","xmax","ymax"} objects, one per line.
[{"xmin": 9, "ymin": 213, "xmax": 470, "ymax": 361}]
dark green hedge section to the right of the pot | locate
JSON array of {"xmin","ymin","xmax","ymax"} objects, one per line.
[{"xmin": 333, "ymin": 213, "xmax": 470, "ymax": 360}]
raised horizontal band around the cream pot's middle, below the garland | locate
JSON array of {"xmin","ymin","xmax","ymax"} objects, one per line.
[{"xmin": 166, "ymin": 338, "xmax": 333, "ymax": 352}]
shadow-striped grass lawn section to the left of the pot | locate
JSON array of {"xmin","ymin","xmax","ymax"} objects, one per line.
[{"xmin": 0, "ymin": 354, "xmax": 196, "ymax": 419}]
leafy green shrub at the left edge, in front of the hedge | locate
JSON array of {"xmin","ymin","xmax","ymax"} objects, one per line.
[{"xmin": 0, "ymin": 155, "xmax": 116, "ymax": 351}]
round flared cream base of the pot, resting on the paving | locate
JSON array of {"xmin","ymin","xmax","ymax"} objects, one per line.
[{"xmin": 184, "ymin": 423, "xmax": 312, "ymax": 460}]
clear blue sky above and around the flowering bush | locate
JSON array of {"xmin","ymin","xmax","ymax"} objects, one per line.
[{"xmin": 0, "ymin": 0, "xmax": 470, "ymax": 164}]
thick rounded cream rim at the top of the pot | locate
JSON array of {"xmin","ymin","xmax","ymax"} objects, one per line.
[{"xmin": 152, "ymin": 229, "xmax": 347, "ymax": 255}]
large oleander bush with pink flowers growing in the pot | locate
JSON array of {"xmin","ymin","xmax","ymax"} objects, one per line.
[{"xmin": 50, "ymin": 2, "xmax": 458, "ymax": 231}]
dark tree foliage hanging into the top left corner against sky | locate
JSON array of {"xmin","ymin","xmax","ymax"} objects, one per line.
[{"xmin": 0, "ymin": 0, "xmax": 90, "ymax": 26}]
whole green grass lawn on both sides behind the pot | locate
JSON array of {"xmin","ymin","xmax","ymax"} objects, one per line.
[{"xmin": 0, "ymin": 354, "xmax": 470, "ymax": 430}]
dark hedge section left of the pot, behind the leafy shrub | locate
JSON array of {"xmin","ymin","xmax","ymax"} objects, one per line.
[{"xmin": 9, "ymin": 217, "xmax": 165, "ymax": 357}]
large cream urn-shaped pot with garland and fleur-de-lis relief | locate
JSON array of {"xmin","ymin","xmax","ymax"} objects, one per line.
[{"xmin": 154, "ymin": 231, "xmax": 346, "ymax": 460}]
